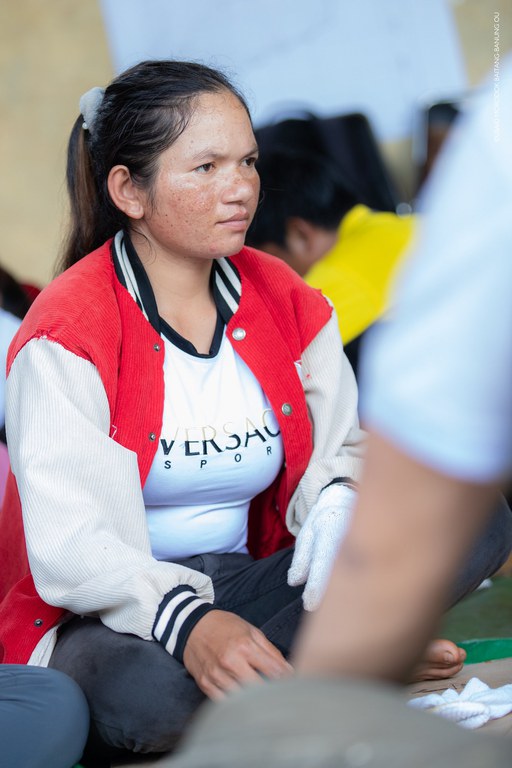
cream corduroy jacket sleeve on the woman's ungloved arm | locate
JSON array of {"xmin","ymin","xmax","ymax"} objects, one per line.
[{"xmin": 6, "ymin": 338, "xmax": 213, "ymax": 653}]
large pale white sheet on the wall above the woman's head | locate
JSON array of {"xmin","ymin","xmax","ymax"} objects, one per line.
[{"xmin": 101, "ymin": 0, "xmax": 467, "ymax": 140}]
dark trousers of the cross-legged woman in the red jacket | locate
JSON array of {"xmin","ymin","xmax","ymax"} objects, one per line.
[{"xmin": 50, "ymin": 501, "xmax": 512, "ymax": 765}]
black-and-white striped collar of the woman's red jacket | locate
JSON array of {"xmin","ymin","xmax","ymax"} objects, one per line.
[{"xmin": 112, "ymin": 230, "xmax": 242, "ymax": 333}]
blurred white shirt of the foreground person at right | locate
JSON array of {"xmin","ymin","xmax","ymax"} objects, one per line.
[{"xmin": 361, "ymin": 59, "xmax": 512, "ymax": 482}]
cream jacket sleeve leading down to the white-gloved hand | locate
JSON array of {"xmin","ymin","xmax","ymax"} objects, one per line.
[{"xmin": 286, "ymin": 310, "xmax": 364, "ymax": 536}]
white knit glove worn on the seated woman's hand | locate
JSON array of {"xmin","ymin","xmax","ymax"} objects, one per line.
[{"xmin": 288, "ymin": 484, "xmax": 357, "ymax": 611}]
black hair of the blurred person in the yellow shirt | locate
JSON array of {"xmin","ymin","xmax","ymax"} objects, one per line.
[{"xmin": 247, "ymin": 149, "xmax": 360, "ymax": 248}]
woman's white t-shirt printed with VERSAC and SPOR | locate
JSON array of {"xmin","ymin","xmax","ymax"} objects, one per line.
[{"xmin": 144, "ymin": 335, "xmax": 284, "ymax": 561}]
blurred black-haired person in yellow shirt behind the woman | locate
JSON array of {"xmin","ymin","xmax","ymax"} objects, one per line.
[{"xmin": 247, "ymin": 149, "xmax": 416, "ymax": 376}]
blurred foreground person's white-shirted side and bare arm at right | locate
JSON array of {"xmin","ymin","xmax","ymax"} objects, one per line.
[{"xmin": 299, "ymin": 60, "xmax": 512, "ymax": 679}]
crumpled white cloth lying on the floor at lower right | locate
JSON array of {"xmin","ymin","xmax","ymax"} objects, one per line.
[{"xmin": 409, "ymin": 677, "xmax": 512, "ymax": 729}]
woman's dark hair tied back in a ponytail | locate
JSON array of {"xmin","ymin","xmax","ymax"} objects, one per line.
[{"xmin": 59, "ymin": 61, "xmax": 249, "ymax": 269}]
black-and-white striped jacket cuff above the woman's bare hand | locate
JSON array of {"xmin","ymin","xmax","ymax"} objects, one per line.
[{"xmin": 152, "ymin": 585, "xmax": 214, "ymax": 664}]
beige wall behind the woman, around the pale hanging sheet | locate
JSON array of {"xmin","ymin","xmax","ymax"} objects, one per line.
[{"xmin": 0, "ymin": 0, "xmax": 512, "ymax": 284}]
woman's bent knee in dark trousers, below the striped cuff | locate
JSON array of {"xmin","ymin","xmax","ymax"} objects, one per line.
[{"xmin": 51, "ymin": 620, "xmax": 204, "ymax": 752}]
